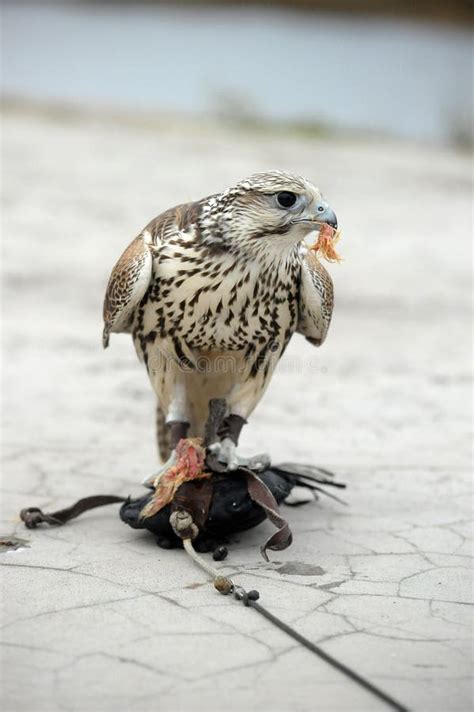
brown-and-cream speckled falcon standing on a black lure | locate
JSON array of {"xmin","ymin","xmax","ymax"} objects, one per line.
[{"xmin": 103, "ymin": 171, "xmax": 337, "ymax": 473}]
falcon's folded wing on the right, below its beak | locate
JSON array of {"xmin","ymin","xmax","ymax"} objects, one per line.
[{"xmin": 297, "ymin": 250, "xmax": 334, "ymax": 346}]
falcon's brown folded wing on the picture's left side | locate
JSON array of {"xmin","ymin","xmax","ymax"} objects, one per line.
[{"xmin": 102, "ymin": 231, "xmax": 153, "ymax": 349}]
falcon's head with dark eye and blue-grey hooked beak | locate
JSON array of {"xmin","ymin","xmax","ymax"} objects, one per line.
[{"xmin": 199, "ymin": 171, "xmax": 337, "ymax": 250}]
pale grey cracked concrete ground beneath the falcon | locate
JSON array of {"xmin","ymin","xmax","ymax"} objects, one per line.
[{"xmin": 0, "ymin": 108, "xmax": 472, "ymax": 712}]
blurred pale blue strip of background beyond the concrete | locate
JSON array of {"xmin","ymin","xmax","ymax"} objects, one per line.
[{"xmin": 2, "ymin": 0, "xmax": 473, "ymax": 144}]
